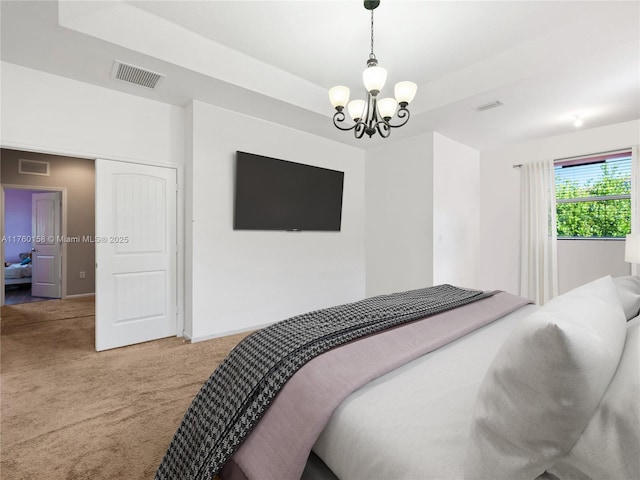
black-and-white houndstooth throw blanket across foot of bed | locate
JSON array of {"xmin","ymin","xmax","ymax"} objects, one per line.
[{"xmin": 155, "ymin": 285, "xmax": 492, "ymax": 480}]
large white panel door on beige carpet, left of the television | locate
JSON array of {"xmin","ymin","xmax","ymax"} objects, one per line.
[{"xmin": 95, "ymin": 160, "xmax": 177, "ymax": 351}]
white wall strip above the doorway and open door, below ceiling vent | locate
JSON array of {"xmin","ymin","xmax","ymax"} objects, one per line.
[{"xmin": 0, "ymin": 62, "xmax": 184, "ymax": 165}]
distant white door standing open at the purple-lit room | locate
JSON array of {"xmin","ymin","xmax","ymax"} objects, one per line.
[{"xmin": 31, "ymin": 192, "xmax": 62, "ymax": 298}]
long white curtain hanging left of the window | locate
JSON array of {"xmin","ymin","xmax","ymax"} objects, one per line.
[{"xmin": 520, "ymin": 160, "xmax": 558, "ymax": 305}]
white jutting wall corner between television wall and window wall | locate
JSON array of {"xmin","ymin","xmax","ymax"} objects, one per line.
[{"xmin": 366, "ymin": 132, "xmax": 479, "ymax": 296}]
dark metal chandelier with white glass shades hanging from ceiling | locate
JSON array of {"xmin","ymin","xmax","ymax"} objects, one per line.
[{"xmin": 329, "ymin": 0, "xmax": 418, "ymax": 138}]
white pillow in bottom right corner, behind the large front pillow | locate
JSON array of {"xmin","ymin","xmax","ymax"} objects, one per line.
[{"xmin": 549, "ymin": 318, "xmax": 640, "ymax": 480}]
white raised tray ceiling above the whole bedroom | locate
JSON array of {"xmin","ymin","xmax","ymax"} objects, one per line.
[{"xmin": 1, "ymin": 0, "xmax": 640, "ymax": 150}]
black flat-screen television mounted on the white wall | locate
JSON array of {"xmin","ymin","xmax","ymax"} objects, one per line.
[{"xmin": 233, "ymin": 152, "xmax": 344, "ymax": 231}]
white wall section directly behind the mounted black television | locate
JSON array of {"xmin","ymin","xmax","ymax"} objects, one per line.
[{"xmin": 186, "ymin": 102, "xmax": 365, "ymax": 339}]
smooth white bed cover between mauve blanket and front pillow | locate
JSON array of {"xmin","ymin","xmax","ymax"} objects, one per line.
[{"xmin": 313, "ymin": 305, "xmax": 537, "ymax": 480}]
